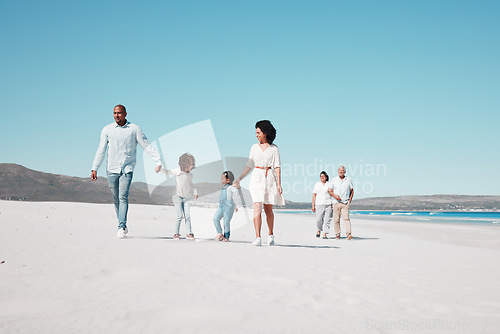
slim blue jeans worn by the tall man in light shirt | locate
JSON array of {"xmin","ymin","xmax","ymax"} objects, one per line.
[{"xmin": 108, "ymin": 172, "xmax": 134, "ymax": 229}]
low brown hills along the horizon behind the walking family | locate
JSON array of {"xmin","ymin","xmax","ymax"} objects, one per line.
[{"xmin": 0, "ymin": 163, "xmax": 500, "ymax": 211}]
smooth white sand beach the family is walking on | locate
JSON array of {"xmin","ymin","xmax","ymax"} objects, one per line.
[{"xmin": 0, "ymin": 201, "xmax": 500, "ymax": 333}]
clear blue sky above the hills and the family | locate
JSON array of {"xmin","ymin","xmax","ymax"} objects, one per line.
[{"xmin": 0, "ymin": 0, "xmax": 500, "ymax": 201}]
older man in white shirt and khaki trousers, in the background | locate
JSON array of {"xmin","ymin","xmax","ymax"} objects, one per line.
[{"xmin": 328, "ymin": 166, "xmax": 354, "ymax": 240}]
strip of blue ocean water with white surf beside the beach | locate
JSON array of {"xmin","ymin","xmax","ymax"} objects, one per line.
[{"xmin": 278, "ymin": 210, "xmax": 500, "ymax": 227}]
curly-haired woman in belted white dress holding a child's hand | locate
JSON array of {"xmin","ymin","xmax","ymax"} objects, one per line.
[{"xmin": 234, "ymin": 120, "xmax": 285, "ymax": 246}]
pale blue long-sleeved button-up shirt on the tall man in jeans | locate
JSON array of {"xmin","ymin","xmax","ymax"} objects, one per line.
[{"xmin": 92, "ymin": 122, "xmax": 161, "ymax": 173}]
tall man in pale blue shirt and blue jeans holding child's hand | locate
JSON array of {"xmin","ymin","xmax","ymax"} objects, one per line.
[{"xmin": 90, "ymin": 104, "xmax": 161, "ymax": 239}]
